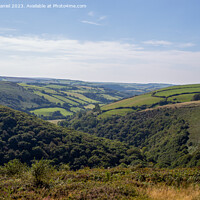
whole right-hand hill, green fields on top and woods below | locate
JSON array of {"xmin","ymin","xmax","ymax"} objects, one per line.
[{"xmin": 60, "ymin": 85, "xmax": 200, "ymax": 167}]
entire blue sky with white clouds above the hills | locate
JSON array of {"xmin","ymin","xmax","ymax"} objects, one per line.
[{"xmin": 0, "ymin": 0, "xmax": 200, "ymax": 84}]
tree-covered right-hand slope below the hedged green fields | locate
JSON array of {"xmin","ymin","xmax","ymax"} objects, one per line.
[{"xmin": 60, "ymin": 96, "xmax": 200, "ymax": 167}]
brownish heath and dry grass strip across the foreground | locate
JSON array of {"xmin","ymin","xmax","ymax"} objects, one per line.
[{"xmin": 0, "ymin": 168, "xmax": 200, "ymax": 200}]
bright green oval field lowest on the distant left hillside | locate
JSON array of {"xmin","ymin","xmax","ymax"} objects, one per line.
[{"xmin": 30, "ymin": 107, "xmax": 73, "ymax": 116}]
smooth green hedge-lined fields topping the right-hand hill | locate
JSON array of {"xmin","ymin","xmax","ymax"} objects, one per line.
[{"xmin": 100, "ymin": 84, "xmax": 200, "ymax": 117}]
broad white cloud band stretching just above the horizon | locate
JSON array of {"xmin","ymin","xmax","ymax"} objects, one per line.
[{"xmin": 0, "ymin": 36, "xmax": 200, "ymax": 83}]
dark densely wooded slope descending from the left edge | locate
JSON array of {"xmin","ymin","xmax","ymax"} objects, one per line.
[{"xmin": 0, "ymin": 106, "xmax": 144, "ymax": 169}]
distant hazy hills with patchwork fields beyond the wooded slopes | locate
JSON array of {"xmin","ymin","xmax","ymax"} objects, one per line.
[{"xmin": 0, "ymin": 77, "xmax": 172, "ymax": 119}]
